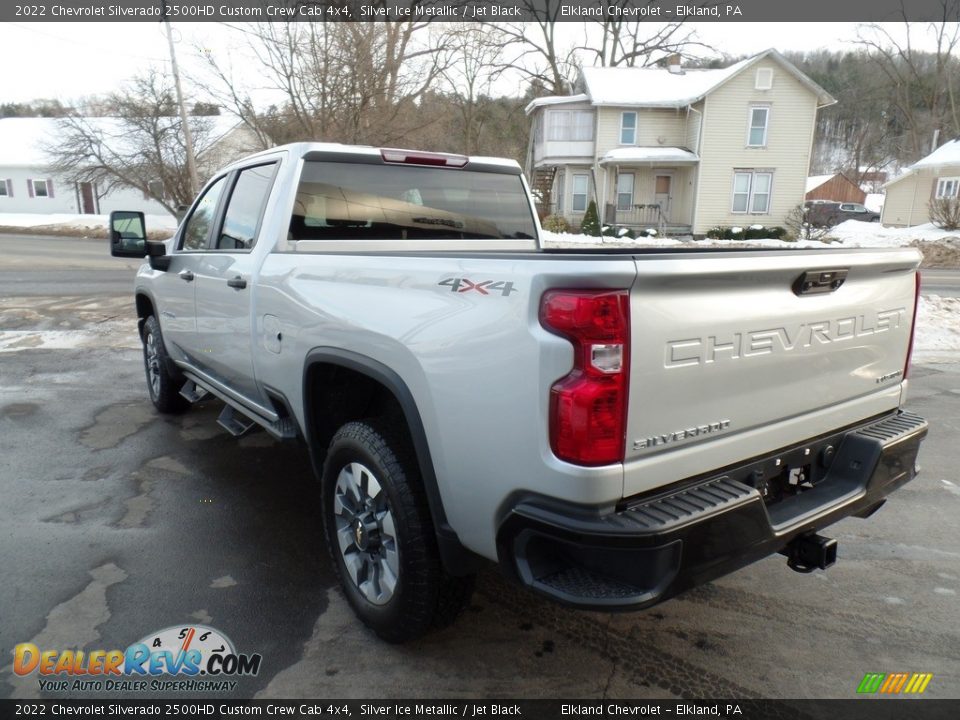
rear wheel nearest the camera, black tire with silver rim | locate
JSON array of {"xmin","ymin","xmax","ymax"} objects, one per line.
[{"xmin": 322, "ymin": 420, "xmax": 474, "ymax": 643}]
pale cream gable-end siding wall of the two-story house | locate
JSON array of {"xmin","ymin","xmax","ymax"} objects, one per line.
[{"xmin": 694, "ymin": 59, "xmax": 817, "ymax": 234}]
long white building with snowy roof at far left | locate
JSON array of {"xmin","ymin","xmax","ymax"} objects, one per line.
[{"xmin": 0, "ymin": 116, "xmax": 254, "ymax": 215}]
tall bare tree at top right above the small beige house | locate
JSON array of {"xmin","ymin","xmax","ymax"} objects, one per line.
[{"xmin": 859, "ymin": 0, "xmax": 960, "ymax": 160}]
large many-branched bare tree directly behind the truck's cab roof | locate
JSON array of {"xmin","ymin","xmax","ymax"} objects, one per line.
[{"xmin": 195, "ymin": 21, "xmax": 450, "ymax": 145}]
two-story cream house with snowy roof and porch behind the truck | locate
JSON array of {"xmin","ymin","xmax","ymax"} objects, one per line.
[{"xmin": 527, "ymin": 49, "xmax": 836, "ymax": 235}]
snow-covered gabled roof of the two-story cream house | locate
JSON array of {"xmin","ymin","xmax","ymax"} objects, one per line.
[{"xmin": 526, "ymin": 48, "xmax": 836, "ymax": 114}]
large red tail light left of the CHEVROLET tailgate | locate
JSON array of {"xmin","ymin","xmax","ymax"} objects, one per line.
[{"xmin": 540, "ymin": 290, "xmax": 630, "ymax": 465}]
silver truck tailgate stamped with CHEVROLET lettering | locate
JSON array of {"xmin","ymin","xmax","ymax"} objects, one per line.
[{"xmin": 624, "ymin": 249, "xmax": 921, "ymax": 495}]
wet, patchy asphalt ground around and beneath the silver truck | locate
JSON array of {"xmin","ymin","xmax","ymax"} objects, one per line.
[{"xmin": 0, "ymin": 238, "xmax": 960, "ymax": 699}]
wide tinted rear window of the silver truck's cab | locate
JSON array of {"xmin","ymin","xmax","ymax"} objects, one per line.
[{"xmin": 290, "ymin": 161, "xmax": 535, "ymax": 240}]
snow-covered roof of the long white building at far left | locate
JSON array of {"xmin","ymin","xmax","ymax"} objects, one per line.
[{"xmin": 0, "ymin": 115, "xmax": 244, "ymax": 167}]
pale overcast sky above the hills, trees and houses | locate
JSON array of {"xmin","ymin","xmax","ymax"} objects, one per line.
[{"xmin": 0, "ymin": 22, "xmax": 944, "ymax": 103}]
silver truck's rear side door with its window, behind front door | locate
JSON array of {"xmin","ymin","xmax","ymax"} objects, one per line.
[{"xmin": 189, "ymin": 162, "xmax": 277, "ymax": 401}]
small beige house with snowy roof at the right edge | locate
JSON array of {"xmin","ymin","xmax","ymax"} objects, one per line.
[{"xmin": 880, "ymin": 138, "xmax": 960, "ymax": 227}]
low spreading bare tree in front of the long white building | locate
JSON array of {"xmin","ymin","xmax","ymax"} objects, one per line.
[{"xmin": 44, "ymin": 71, "xmax": 223, "ymax": 213}]
